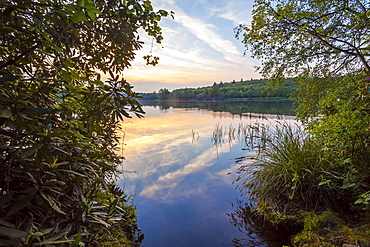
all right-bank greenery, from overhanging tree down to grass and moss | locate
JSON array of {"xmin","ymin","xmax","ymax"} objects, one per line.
[{"xmin": 228, "ymin": 0, "xmax": 370, "ymax": 247}]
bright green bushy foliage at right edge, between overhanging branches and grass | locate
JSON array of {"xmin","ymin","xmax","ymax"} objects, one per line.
[{"xmin": 299, "ymin": 74, "xmax": 370, "ymax": 208}]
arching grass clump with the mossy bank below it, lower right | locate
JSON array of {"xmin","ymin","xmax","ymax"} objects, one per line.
[{"xmin": 234, "ymin": 121, "xmax": 370, "ymax": 246}]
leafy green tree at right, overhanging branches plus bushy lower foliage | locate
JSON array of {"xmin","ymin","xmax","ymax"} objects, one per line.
[{"xmin": 236, "ymin": 0, "xmax": 370, "ymax": 220}]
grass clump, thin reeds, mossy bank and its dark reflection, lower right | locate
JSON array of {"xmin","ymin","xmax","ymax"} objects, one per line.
[{"xmin": 212, "ymin": 118, "xmax": 370, "ymax": 247}]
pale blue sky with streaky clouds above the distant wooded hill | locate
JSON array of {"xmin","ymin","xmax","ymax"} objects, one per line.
[{"xmin": 124, "ymin": 0, "xmax": 260, "ymax": 92}]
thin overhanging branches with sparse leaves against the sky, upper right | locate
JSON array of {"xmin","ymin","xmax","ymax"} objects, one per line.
[{"xmin": 236, "ymin": 0, "xmax": 370, "ymax": 79}]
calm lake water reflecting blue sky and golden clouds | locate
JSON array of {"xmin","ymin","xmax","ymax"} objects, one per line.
[{"xmin": 119, "ymin": 102, "xmax": 294, "ymax": 247}]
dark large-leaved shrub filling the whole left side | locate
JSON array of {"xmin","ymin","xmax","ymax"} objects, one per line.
[{"xmin": 0, "ymin": 0, "xmax": 167, "ymax": 246}]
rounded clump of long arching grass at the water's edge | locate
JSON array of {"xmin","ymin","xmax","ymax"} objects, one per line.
[{"xmin": 239, "ymin": 121, "xmax": 346, "ymax": 213}]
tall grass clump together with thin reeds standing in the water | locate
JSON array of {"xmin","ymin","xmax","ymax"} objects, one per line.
[{"xmin": 212, "ymin": 119, "xmax": 370, "ymax": 213}]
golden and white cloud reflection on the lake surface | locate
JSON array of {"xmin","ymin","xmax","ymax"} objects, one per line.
[{"xmin": 123, "ymin": 108, "xmax": 282, "ymax": 201}]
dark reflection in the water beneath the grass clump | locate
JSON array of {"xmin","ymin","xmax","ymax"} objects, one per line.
[{"xmin": 228, "ymin": 200, "xmax": 302, "ymax": 247}]
